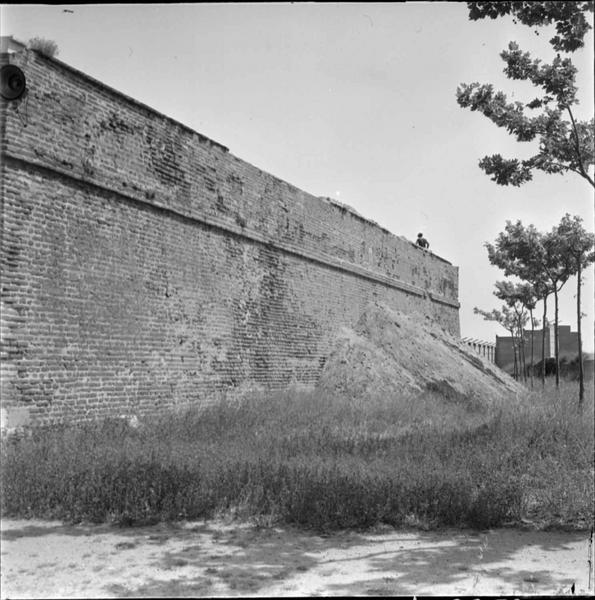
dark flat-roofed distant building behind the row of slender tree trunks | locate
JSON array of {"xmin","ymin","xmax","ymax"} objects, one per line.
[{"xmin": 495, "ymin": 325, "xmax": 593, "ymax": 374}]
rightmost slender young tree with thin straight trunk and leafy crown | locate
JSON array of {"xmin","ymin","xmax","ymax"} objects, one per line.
[{"xmin": 556, "ymin": 213, "xmax": 595, "ymax": 405}]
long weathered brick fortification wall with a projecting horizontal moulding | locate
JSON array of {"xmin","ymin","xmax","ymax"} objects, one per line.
[{"xmin": 0, "ymin": 52, "xmax": 459, "ymax": 424}]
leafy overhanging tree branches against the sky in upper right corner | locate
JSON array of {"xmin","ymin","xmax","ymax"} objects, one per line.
[{"xmin": 457, "ymin": 2, "xmax": 595, "ymax": 187}]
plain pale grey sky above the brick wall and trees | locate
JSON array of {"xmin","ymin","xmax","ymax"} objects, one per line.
[{"xmin": 0, "ymin": 2, "xmax": 595, "ymax": 352}]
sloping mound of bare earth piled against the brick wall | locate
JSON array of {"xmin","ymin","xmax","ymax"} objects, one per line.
[{"xmin": 318, "ymin": 304, "xmax": 522, "ymax": 404}]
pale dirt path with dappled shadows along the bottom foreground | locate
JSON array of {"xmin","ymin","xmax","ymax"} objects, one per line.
[{"xmin": 2, "ymin": 520, "xmax": 588, "ymax": 598}]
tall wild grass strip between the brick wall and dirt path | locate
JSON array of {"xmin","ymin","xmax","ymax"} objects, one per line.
[{"xmin": 0, "ymin": 383, "xmax": 593, "ymax": 531}]
